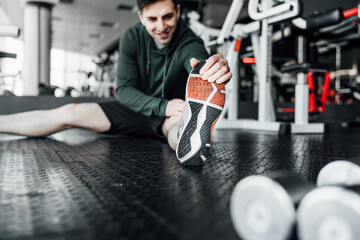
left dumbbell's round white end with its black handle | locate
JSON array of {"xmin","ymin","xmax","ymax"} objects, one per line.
[{"xmin": 230, "ymin": 172, "xmax": 314, "ymax": 240}]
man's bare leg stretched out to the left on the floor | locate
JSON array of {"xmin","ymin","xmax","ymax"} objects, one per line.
[{"xmin": 0, "ymin": 103, "xmax": 110, "ymax": 137}]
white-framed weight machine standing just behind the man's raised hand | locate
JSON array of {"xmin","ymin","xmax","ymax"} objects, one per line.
[{"xmin": 190, "ymin": 0, "xmax": 300, "ymax": 131}]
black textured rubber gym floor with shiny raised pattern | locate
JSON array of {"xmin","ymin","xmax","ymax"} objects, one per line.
[{"xmin": 0, "ymin": 127, "xmax": 360, "ymax": 240}]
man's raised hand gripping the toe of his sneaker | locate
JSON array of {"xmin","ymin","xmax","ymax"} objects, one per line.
[{"xmin": 190, "ymin": 54, "xmax": 232, "ymax": 84}]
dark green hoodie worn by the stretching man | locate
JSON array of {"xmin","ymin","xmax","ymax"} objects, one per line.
[{"xmin": 116, "ymin": 19, "xmax": 209, "ymax": 117}]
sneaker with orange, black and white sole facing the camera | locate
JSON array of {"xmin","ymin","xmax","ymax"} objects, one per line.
[{"xmin": 176, "ymin": 61, "xmax": 225, "ymax": 166}]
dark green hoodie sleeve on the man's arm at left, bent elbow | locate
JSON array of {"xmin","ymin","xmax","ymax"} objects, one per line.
[{"xmin": 116, "ymin": 30, "xmax": 168, "ymax": 117}]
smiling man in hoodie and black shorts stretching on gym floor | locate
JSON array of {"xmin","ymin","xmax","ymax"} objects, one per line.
[{"xmin": 0, "ymin": 0, "xmax": 231, "ymax": 165}]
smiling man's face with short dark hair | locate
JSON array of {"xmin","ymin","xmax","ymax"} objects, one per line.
[{"xmin": 138, "ymin": 0, "xmax": 180, "ymax": 45}]
